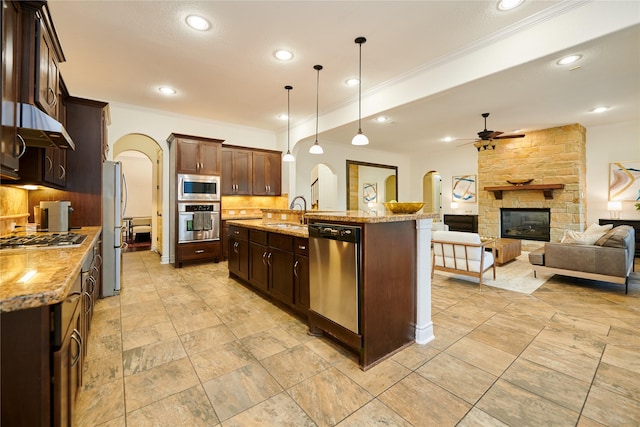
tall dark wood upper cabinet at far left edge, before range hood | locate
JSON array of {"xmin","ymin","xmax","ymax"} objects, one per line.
[{"xmin": 0, "ymin": 0, "xmax": 26, "ymax": 179}]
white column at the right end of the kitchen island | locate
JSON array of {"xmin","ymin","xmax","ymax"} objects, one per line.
[{"xmin": 416, "ymin": 218, "xmax": 435, "ymax": 344}]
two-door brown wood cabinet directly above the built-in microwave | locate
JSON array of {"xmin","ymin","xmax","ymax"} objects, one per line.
[{"xmin": 167, "ymin": 133, "xmax": 222, "ymax": 175}]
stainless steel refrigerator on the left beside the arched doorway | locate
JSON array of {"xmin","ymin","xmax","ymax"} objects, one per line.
[{"xmin": 101, "ymin": 162, "xmax": 126, "ymax": 297}]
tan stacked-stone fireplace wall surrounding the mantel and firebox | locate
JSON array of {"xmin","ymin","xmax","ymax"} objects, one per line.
[{"xmin": 477, "ymin": 124, "xmax": 586, "ymax": 251}]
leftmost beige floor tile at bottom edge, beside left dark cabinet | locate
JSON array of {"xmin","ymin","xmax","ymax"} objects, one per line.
[{"xmin": 73, "ymin": 380, "xmax": 125, "ymax": 426}]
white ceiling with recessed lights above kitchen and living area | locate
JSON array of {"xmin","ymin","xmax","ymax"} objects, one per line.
[{"xmin": 49, "ymin": 0, "xmax": 640, "ymax": 153}]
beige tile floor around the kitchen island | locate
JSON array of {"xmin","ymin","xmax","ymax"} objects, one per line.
[{"xmin": 74, "ymin": 251, "xmax": 640, "ymax": 427}]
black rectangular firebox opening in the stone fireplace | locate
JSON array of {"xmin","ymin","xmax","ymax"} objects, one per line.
[{"xmin": 500, "ymin": 208, "xmax": 551, "ymax": 242}]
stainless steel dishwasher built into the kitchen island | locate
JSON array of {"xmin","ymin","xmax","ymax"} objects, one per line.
[{"xmin": 309, "ymin": 223, "xmax": 362, "ymax": 334}]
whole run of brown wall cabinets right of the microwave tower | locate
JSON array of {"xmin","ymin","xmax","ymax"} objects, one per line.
[{"xmin": 220, "ymin": 145, "xmax": 282, "ymax": 196}]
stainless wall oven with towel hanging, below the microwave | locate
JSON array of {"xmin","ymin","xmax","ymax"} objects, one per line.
[{"xmin": 178, "ymin": 202, "xmax": 220, "ymax": 243}]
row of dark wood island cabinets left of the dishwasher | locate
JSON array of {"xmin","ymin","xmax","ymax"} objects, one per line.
[{"xmin": 228, "ymin": 225, "xmax": 309, "ymax": 315}]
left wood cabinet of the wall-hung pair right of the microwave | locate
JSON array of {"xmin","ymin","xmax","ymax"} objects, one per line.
[{"xmin": 220, "ymin": 146, "xmax": 253, "ymax": 196}]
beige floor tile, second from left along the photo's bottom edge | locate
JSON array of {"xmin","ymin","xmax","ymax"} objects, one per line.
[{"xmin": 127, "ymin": 385, "xmax": 219, "ymax": 427}]
